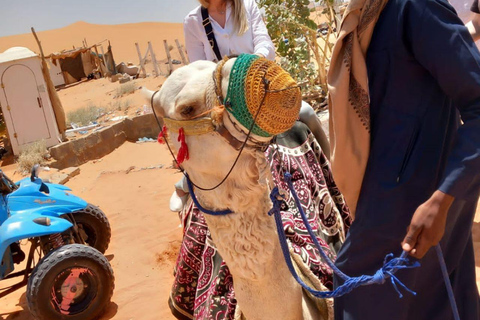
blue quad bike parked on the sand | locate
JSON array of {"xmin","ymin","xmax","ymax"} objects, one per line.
[{"xmin": 0, "ymin": 165, "xmax": 114, "ymax": 320}]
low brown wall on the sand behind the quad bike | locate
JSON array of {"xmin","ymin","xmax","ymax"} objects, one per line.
[{"xmin": 49, "ymin": 113, "xmax": 163, "ymax": 169}]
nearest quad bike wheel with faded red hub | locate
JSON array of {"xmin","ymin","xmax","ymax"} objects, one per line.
[{"xmin": 27, "ymin": 244, "xmax": 114, "ymax": 320}]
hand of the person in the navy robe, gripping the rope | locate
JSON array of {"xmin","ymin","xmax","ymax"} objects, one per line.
[{"xmin": 402, "ymin": 190, "xmax": 454, "ymax": 259}]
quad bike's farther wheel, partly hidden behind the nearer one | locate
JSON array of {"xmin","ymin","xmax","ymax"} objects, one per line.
[{"xmin": 73, "ymin": 204, "xmax": 112, "ymax": 253}]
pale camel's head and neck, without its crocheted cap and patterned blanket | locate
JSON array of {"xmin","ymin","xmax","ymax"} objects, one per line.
[{"xmin": 146, "ymin": 58, "xmax": 333, "ymax": 320}]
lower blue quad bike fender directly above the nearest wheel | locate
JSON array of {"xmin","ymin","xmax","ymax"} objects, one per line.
[{"xmin": 0, "ymin": 212, "xmax": 73, "ymax": 266}]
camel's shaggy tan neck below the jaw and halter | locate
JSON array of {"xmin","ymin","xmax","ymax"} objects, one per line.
[{"xmin": 188, "ymin": 150, "xmax": 303, "ymax": 320}]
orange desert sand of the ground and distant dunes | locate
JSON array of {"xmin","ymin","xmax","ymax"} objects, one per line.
[{"xmin": 0, "ymin": 22, "xmax": 480, "ymax": 320}]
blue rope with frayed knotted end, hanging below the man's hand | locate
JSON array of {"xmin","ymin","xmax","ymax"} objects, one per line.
[{"xmin": 269, "ymin": 181, "xmax": 420, "ymax": 299}]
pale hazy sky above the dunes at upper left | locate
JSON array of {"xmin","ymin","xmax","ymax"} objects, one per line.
[{"xmin": 0, "ymin": 0, "xmax": 198, "ymax": 37}]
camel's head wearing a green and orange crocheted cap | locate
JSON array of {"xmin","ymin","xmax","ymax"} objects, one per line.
[{"xmin": 144, "ymin": 55, "xmax": 301, "ymax": 180}]
